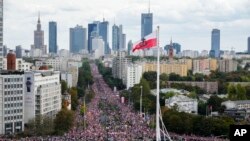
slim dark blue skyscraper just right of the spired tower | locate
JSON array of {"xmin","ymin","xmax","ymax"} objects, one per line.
[{"xmin": 49, "ymin": 21, "xmax": 57, "ymax": 54}]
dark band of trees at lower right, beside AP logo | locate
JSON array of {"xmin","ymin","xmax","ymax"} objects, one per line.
[{"xmin": 163, "ymin": 110, "xmax": 234, "ymax": 136}]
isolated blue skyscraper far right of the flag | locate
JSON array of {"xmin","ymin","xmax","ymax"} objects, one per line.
[{"xmin": 210, "ymin": 29, "xmax": 220, "ymax": 58}]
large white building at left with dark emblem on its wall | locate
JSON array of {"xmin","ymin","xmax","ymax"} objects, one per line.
[{"xmin": 24, "ymin": 70, "xmax": 62, "ymax": 123}]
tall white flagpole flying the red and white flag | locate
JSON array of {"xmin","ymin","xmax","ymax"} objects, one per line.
[{"xmin": 156, "ymin": 26, "xmax": 161, "ymax": 141}]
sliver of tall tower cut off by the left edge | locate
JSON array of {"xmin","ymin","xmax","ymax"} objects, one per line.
[{"xmin": 0, "ymin": 0, "xmax": 3, "ymax": 70}]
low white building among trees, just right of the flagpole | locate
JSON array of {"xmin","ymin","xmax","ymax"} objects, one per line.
[{"xmin": 165, "ymin": 95, "xmax": 198, "ymax": 114}]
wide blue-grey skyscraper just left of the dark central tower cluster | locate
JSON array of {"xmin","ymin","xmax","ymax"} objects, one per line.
[{"xmin": 69, "ymin": 25, "xmax": 87, "ymax": 53}]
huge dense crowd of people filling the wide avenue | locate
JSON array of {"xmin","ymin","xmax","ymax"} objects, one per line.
[{"xmin": 0, "ymin": 64, "xmax": 229, "ymax": 141}]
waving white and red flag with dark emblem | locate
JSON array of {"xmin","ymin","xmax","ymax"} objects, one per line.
[{"xmin": 132, "ymin": 31, "xmax": 157, "ymax": 52}]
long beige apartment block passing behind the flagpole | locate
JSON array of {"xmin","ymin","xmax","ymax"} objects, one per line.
[{"xmin": 143, "ymin": 62, "xmax": 187, "ymax": 76}]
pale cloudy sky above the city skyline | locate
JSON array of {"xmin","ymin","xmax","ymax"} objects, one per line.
[{"xmin": 4, "ymin": 0, "xmax": 250, "ymax": 52}]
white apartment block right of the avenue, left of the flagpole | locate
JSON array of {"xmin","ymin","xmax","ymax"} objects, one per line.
[{"xmin": 123, "ymin": 64, "xmax": 142, "ymax": 89}]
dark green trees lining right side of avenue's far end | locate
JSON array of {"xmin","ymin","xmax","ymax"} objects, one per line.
[{"xmin": 96, "ymin": 60, "xmax": 126, "ymax": 90}]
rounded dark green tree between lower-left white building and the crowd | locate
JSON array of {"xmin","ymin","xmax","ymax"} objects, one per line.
[{"xmin": 54, "ymin": 109, "xmax": 74, "ymax": 135}]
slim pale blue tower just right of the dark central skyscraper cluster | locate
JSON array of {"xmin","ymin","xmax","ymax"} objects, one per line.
[{"xmin": 112, "ymin": 24, "xmax": 119, "ymax": 51}]
